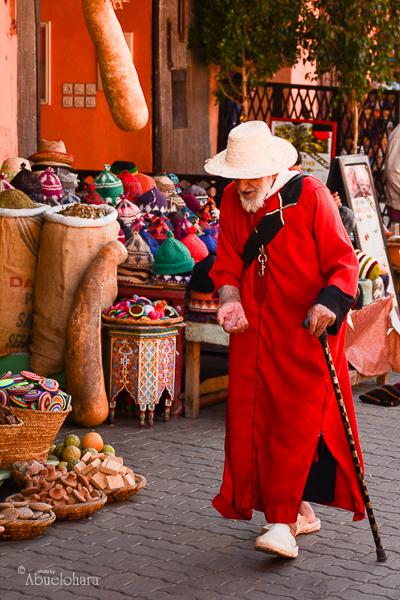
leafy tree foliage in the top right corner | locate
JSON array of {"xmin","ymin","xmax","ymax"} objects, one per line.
[{"xmin": 300, "ymin": 0, "xmax": 400, "ymax": 101}]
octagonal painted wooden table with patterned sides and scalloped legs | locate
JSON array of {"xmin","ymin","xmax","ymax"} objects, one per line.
[{"xmin": 103, "ymin": 322, "xmax": 182, "ymax": 426}]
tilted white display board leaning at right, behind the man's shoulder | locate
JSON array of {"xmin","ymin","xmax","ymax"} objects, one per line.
[{"xmin": 327, "ymin": 154, "xmax": 399, "ymax": 309}]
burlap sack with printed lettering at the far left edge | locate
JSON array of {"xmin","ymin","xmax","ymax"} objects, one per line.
[{"xmin": 0, "ymin": 206, "xmax": 48, "ymax": 356}]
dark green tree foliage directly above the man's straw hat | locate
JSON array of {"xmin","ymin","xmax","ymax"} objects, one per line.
[{"xmin": 189, "ymin": 0, "xmax": 303, "ymax": 109}]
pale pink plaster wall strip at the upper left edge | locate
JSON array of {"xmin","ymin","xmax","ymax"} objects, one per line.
[{"xmin": 0, "ymin": 0, "xmax": 18, "ymax": 166}]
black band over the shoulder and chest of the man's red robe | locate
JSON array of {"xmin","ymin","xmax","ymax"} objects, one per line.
[{"xmin": 243, "ymin": 173, "xmax": 307, "ymax": 267}]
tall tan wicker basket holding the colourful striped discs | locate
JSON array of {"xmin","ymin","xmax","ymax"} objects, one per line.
[{"xmin": 0, "ymin": 406, "xmax": 70, "ymax": 469}]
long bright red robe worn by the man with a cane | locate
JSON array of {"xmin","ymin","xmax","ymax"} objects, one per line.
[{"xmin": 211, "ymin": 177, "xmax": 364, "ymax": 523}]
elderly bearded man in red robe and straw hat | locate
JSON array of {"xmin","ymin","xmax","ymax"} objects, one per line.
[{"xmin": 205, "ymin": 121, "xmax": 364, "ymax": 558}]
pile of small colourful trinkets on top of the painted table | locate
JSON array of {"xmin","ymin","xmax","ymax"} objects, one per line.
[{"xmin": 103, "ymin": 294, "xmax": 183, "ymax": 325}]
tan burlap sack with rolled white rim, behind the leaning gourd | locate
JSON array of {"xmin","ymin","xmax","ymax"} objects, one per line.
[{"xmin": 31, "ymin": 206, "xmax": 119, "ymax": 375}]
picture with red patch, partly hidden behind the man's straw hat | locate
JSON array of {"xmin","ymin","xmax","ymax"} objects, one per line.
[{"xmin": 271, "ymin": 117, "xmax": 336, "ymax": 183}]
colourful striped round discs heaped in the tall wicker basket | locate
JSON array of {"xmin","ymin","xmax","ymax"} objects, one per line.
[{"xmin": 0, "ymin": 371, "xmax": 71, "ymax": 413}]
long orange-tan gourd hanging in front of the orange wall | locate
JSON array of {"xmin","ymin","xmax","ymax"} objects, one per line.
[{"xmin": 82, "ymin": 0, "xmax": 149, "ymax": 131}]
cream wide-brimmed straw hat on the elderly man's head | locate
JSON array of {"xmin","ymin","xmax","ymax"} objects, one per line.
[{"xmin": 204, "ymin": 121, "xmax": 297, "ymax": 179}]
